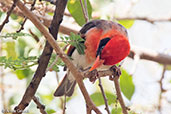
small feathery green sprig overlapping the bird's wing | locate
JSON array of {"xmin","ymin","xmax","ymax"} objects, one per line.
[{"xmin": 61, "ymin": 33, "xmax": 85, "ymax": 54}]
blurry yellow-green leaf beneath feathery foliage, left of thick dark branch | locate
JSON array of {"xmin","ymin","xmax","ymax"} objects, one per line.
[{"xmin": 15, "ymin": 69, "xmax": 33, "ymax": 80}]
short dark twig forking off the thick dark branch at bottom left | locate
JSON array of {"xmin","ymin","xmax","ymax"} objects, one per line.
[{"xmin": 33, "ymin": 96, "xmax": 47, "ymax": 114}]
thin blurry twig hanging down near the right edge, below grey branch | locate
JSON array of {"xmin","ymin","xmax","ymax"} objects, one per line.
[{"xmin": 157, "ymin": 65, "xmax": 166, "ymax": 114}]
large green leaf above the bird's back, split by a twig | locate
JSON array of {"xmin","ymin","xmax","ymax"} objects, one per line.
[{"xmin": 67, "ymin": 0, "xmax": 92, "ymax": 26}]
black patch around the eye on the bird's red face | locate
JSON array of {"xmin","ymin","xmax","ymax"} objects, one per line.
[{"xmin": 96, "ymin": 37, "xmax": 110, "ymax": 57}]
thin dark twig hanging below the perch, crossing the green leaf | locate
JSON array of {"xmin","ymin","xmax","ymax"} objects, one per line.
[{"xmin": 99, "ymin": 77, "xmax": 110, "ymax": 114}]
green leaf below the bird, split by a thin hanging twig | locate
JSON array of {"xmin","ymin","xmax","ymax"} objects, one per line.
[{"xmin": 90, "ymin": 92, "xmax": 116, "ymax": 106}]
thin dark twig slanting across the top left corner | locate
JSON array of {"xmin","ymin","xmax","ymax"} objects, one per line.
[{"xmin": 0, "ymin": 0, "xmax": 18, "ymax": 33}]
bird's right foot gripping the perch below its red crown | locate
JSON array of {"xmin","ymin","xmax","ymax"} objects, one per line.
[{"xmin": 109, "ymin": 65, "xmax": 121, "ymax": 80}]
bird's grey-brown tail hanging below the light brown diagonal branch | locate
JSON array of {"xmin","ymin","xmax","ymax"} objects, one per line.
[{"xmin": 54, "ymin": 74, "xmax": 76, "ymax": 97}]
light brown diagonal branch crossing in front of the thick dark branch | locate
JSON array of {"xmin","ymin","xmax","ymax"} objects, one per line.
[{"xmin": 14, "ymin": 1, "xmax": 101, "ymax": 114}]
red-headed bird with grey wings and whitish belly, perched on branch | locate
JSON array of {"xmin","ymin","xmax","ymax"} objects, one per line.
[{"xmin": 54, "ymin": 19, "xmax": 130, "ymax": 97}]
